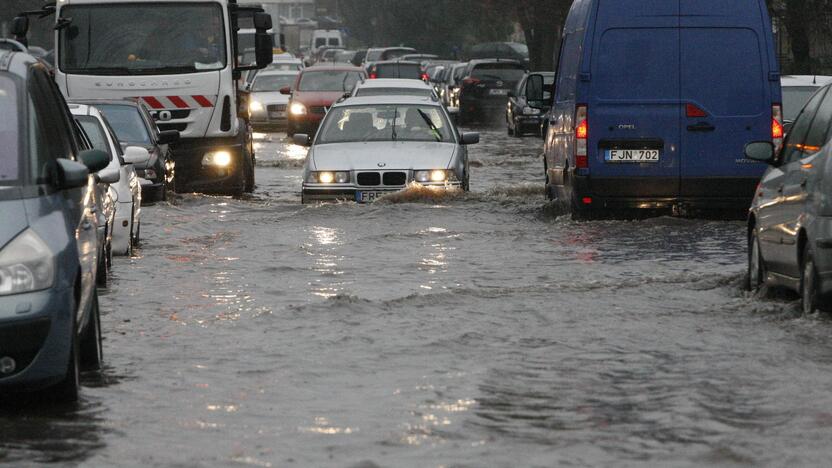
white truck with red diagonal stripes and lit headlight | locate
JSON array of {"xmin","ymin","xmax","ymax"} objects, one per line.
[{"xmin": 16, "ymin": 0, "xmax": 273, "ymax": 195}]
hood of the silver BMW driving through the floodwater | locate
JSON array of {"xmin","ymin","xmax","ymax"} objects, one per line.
[{"xmin": 310, "ymin": 141, "xmax": 456, "ymax": 171}]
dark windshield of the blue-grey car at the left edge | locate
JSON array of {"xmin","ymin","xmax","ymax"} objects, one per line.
[{"xmin": 0, "ymin": 74, "xmax": 21, "ymax": 185}]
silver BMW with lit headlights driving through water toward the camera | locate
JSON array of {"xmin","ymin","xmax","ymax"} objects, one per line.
[{"xmin": 294, "ymin": 96, "xmax": 480, "ymax": 203}]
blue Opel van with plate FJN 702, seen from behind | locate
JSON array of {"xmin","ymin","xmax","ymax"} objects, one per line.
[{"xmin": 545, "ymin": 0, "xmax": 783, "ymax": 218}]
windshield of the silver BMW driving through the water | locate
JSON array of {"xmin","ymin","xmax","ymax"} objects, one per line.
[{"xmin": 316, "ymin": 105, "xmax": 454, "ymax": 144}]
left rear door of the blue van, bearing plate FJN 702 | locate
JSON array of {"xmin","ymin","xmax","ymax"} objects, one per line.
[{"xmin": 588, "ymin": 0, "xmax": 680, "ymax": 199}]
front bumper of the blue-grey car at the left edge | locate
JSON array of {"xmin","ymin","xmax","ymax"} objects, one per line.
[{"xmin": 0, "ymin": 289, "xmax": 75, "ymax": 391}]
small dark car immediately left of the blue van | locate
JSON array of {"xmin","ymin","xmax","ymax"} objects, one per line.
[{"xmin": 506, "ymin": 72, "xmax": 555, "ymax": 137}]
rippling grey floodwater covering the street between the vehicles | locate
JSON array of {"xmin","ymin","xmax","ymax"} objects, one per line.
[{"xmin": 0, "ymin": 130, "xmax": 832, "ymax": 468}]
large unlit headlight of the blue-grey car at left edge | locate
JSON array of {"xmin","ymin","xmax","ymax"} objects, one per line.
[{"xmin": 0, "ymin": 229, "xmax": 55, "ymax": 296}]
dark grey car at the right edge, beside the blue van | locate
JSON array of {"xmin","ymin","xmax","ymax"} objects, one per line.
[{"xmin": 745, "ymin": 85, "xmax": 832, "ymax": 314}]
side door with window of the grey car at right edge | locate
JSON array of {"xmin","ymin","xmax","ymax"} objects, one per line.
[{"xmin": 758, "ymin": 89, "xmax": 826, "ymax": 277}]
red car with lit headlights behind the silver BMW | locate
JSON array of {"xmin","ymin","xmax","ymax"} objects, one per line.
[{"xmin": 280, "ymin": 65, "xmax": 367, "ymax": 137}]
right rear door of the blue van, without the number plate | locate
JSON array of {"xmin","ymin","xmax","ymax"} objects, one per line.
[{"xmin": 680, "ymin": 0, "xmax": 774, "ymax": 201}]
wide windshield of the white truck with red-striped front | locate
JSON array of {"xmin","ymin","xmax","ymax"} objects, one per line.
[{"xmin": 59, "ymin": 3, "xmax": 227, "ymax": 75}]
